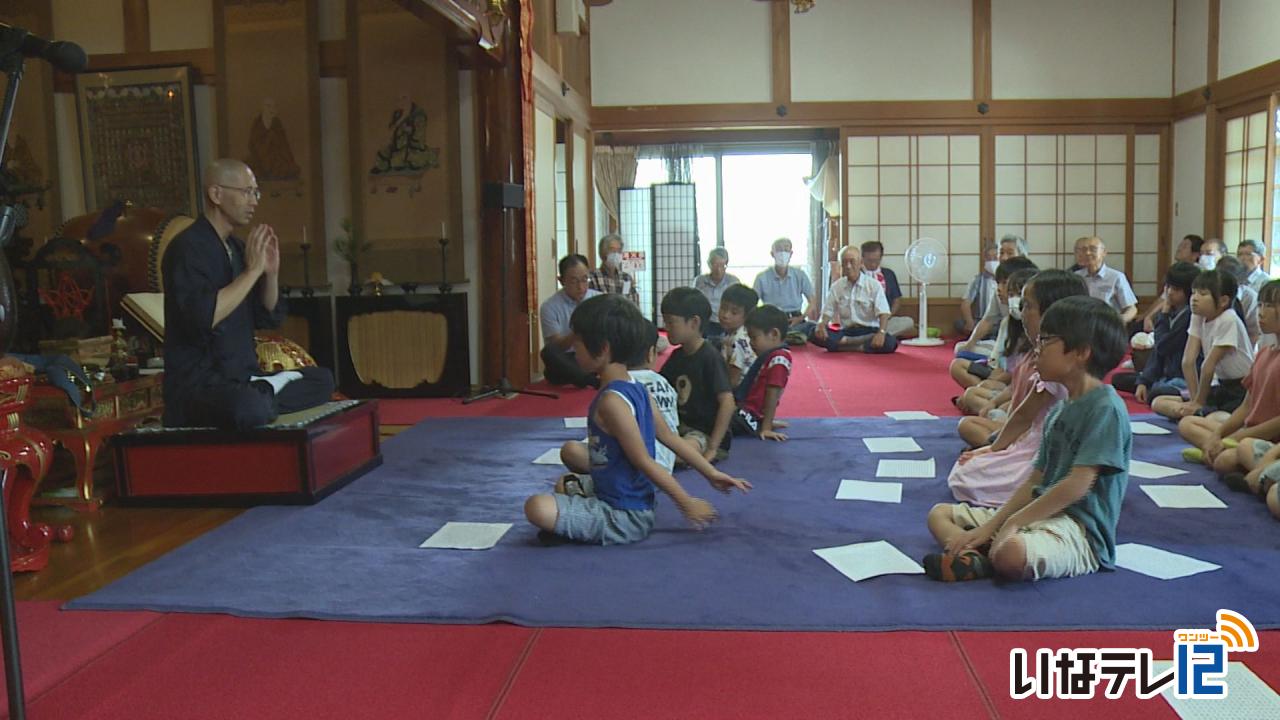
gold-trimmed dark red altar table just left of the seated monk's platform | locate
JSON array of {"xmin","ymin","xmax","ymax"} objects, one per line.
[{"xmin": 23, "ymin": 374, "xmax": 164, "ymax": 510}]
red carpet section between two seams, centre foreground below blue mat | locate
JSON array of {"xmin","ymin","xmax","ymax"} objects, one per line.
[{"xmin": 497, "ymin": 629, "xmax": 986, "ymax": 720}]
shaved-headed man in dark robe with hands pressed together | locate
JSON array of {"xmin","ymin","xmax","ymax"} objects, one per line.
[{"xmin": 161, "ymin": 160, "xmax": 334, "ymax": 429}]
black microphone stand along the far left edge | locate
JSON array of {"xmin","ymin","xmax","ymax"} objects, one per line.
[{"xmin": 0, "ymin": 28, "xmax": 27, "ymax": 720}]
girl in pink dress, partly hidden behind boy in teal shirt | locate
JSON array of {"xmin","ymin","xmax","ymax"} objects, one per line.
[{"xmin": 947, "ymin": 270, "xmax": 1089, "ymax": 507}]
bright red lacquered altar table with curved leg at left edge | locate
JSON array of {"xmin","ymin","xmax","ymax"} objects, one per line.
[{"xmin": 0, "ymin": 377, "xmax": 72, "ymax": 573}]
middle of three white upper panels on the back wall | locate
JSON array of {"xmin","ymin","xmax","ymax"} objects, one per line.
[{"xmin": 788, "ymin": 0, "xmax": 973, "ymax": 102}]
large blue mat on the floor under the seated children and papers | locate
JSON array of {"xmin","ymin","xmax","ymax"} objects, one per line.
[{"xmin": 69, "ymin": 418, "xmax": 1280, "ymax": 630}]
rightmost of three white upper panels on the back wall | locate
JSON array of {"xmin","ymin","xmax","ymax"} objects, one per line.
[{"xmin": 991, "ymin": 0, "xmax": 1174, "ymax": 99}]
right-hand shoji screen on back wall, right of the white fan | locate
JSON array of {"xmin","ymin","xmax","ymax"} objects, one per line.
[{"xmin": 995, "ymin": 133, "xmax": 1160, "ymax": 295}]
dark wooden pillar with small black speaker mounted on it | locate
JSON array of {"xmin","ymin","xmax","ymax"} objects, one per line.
[{"xmin": 476, "ymin": 0, "xmax": 530, "ymax": 388}]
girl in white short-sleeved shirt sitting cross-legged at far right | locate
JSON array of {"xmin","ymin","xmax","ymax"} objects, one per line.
[{"xmin": 1151, "ymin": 270, "xmax": 1253, "ymax": 422}]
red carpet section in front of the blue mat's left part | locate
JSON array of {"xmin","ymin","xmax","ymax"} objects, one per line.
[{"xmin": 12, "ymin": 612, "xmax": 534, "ymax": 720}]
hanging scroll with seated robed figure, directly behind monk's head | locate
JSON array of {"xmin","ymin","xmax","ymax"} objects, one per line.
[{"xmin": 214, "ymin": 0, "xmax": 328, "ymax": 287}]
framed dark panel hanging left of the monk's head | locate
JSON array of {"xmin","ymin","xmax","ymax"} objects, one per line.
[{"xmin": 76, "ymin": 65, "xmax": 201, "ymax": 217}]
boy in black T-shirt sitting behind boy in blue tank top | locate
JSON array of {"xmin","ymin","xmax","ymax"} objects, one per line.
[{"xmin": 662, "ymin": 287, "xmax": 736, "ymax": 460}]
